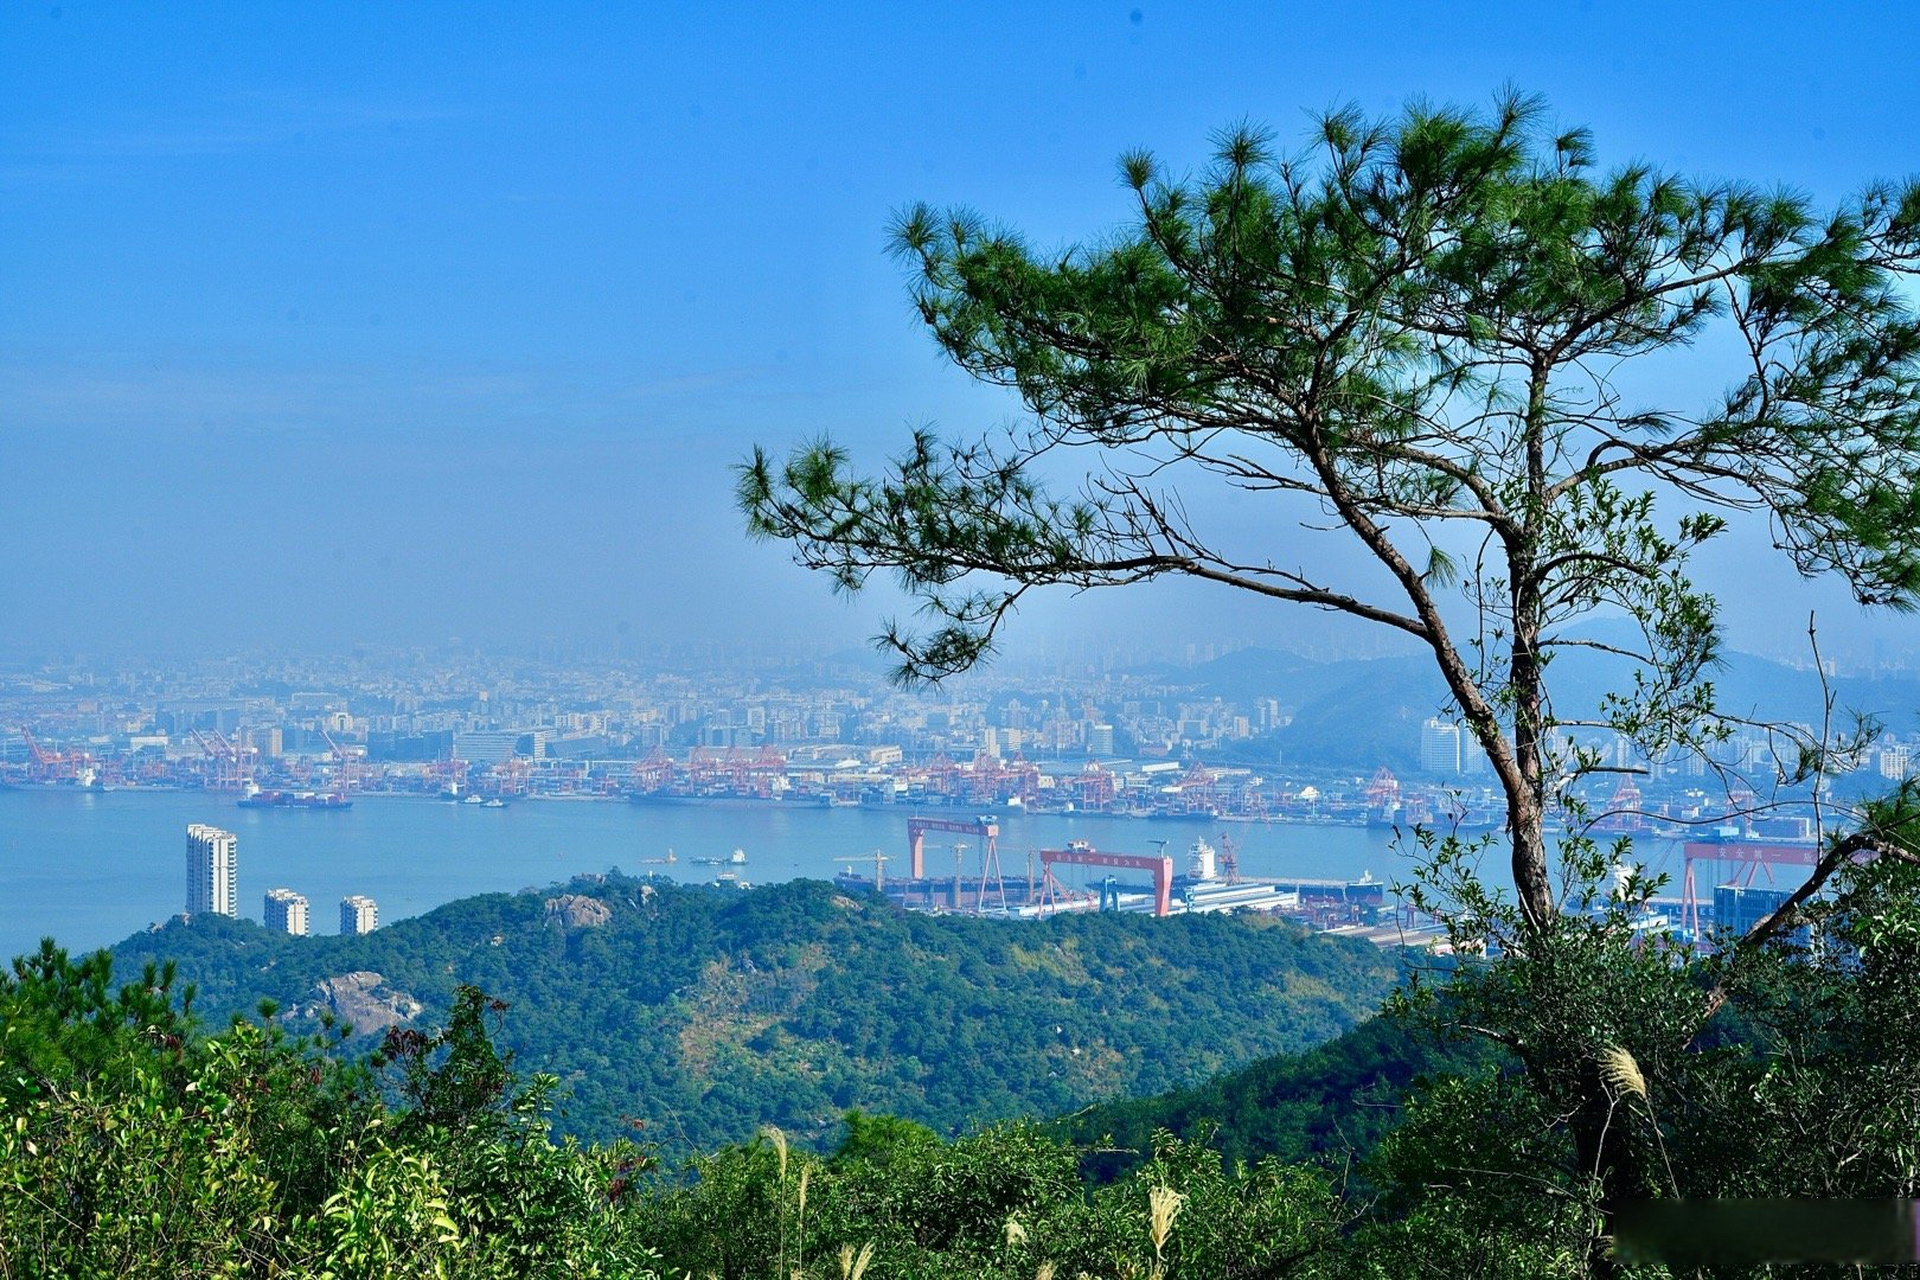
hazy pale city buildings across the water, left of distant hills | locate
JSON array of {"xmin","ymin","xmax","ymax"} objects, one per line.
[{"xmin": 0, "ymin": 640, "xmax": 1288, "ymax": 789}]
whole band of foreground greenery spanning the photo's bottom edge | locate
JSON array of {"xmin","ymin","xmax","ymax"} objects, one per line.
[{"xmin": 18, "ymin": 867, "xmax": 1920, "ymax": 1280}]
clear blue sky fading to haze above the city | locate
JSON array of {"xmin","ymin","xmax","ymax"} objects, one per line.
[{"xmin": 11, "ymin": 0, "xmax": 1920, "ymax": 671}]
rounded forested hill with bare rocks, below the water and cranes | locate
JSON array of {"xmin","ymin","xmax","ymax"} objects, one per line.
[{"xmin": 115, "ymin": 875, "xmax": 1396, "ymax": 1151}]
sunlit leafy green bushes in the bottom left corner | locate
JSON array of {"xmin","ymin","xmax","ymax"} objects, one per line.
[{"xmin": 0, "ymin": 952, "xmax": 653, "ymax": 1276}]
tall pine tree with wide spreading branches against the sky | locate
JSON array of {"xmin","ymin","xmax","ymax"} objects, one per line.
[{"xmin": 739, "ymin": 94, "xmax": 1920, "ymax": 929}]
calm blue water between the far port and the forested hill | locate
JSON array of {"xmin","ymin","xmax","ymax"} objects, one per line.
[{"xmin": 0, "ymin": 791, "xmax": 1405, "ymax": 956}]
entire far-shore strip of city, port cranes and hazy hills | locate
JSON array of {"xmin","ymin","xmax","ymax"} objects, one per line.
[{"xmin": 11, "ymin": 647, "xmax": 1920, "ymax": 825}]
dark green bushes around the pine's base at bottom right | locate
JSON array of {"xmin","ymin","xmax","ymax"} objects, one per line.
[{"xmin": 1356, "ymin": 805, "xmax": 1920, "ymax": 1276}]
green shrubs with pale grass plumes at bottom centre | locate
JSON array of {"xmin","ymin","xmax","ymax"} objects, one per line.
[{"xmin": 639, "ymin": 1125, "xmax": 1350, "ymax": 1280}]
